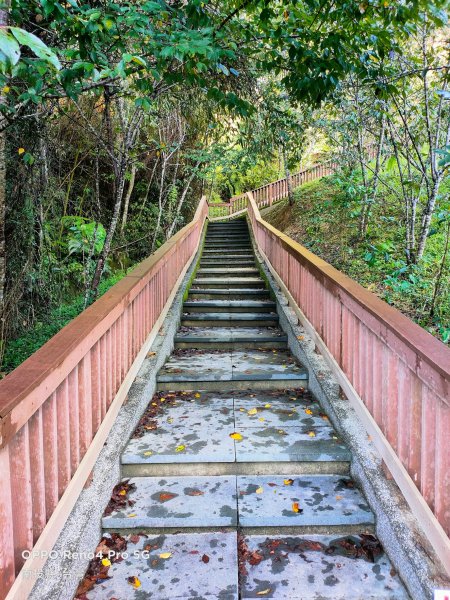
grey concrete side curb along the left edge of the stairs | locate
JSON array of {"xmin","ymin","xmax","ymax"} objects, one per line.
[{"xmin": 28, "ymin": 244, "xmax": 201, "ymax": 600}]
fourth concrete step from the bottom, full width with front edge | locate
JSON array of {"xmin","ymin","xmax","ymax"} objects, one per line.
[{"xmin": 157, "ymin": 350, "xmax": 308, "ymax": 391}]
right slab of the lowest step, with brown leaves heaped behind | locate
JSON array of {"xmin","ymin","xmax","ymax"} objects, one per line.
[{"xmin": 240, "ymin": 535, "xmax": 409, "ymax": 600}]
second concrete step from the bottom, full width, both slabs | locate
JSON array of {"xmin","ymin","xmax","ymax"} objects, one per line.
[{"xmin": 102, "ymin": 473, "xmax": 374, "ymax": 533}]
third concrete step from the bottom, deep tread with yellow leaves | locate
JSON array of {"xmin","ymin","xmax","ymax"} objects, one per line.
[{"xmin": 122, "ymin": 388, "xmax": 350, "ymax": 476}]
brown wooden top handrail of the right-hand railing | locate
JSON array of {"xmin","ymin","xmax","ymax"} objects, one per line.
[{"xmin": 247, "ymin": 192, "xmax": 450, "ymax": 396}]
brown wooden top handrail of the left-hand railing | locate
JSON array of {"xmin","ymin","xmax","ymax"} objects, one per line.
[{"xmin": 0, "ymin": 196, "xmax": 206, "ymax": 447}]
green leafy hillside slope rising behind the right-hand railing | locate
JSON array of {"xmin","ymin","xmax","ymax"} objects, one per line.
[{"xmin": 262, "ymin": 177, "xmax": 450, "ymax": 343}]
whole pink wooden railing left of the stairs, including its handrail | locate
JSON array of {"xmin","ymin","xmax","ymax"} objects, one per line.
[{"xmin": 0, "ymin": 198, "xmax": 208, "ymax": 598}]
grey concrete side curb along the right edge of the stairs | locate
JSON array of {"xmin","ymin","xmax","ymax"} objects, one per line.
[{"xmin": 253, "ymin": 224, "xmax": 449, "ymax": 600}]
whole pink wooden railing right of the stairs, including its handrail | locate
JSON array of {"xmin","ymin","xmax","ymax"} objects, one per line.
[{"xmin": 248, "ymin": 192, "xmax": 450, "ymax": 572}]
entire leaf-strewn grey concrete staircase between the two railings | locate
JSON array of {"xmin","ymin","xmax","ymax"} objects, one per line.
[{"xmin": 82, "ymin": 220, "xmax": 407, "ymax": 600}]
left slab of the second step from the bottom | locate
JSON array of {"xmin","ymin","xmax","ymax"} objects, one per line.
[{"xmin": 102, "ymin": 476, "xmax": 237, "ymax": 529}]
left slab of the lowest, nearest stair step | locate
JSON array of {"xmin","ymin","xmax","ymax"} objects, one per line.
[{"xmin": 86, "ymin": 532, "xmax": 238, "ymax": 600}]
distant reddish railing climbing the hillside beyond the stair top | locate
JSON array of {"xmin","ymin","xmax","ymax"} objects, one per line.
[{"xmin": 209, "ymin": 160, "xmax": 338, "ymax": 220}]
